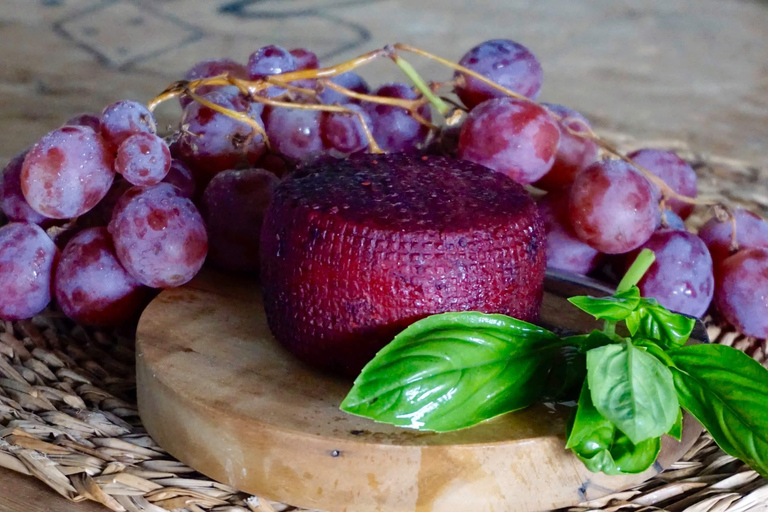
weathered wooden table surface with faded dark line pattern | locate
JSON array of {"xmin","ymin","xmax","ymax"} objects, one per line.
[{"xmin": 0, "ymin": 0, "xmax": 768, "ymax": 512}]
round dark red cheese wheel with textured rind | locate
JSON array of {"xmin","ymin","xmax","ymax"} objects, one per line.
[{"xmin": 261, "ymin": 154, "xmax": 546, "ymax": 375}]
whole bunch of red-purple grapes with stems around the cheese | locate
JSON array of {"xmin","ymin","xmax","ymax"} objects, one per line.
[{"xmin": 0, "ymin": 39, "xmax": 768, "ymax": 344}]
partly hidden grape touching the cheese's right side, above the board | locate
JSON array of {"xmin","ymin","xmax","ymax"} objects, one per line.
[{"xmin": 538, "ymin": 190, "xmax": 601, "ymax": 275}]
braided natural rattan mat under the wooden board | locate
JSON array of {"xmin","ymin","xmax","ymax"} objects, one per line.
[{"xmin": 0, "ymin": 138, "xmax": 768, "ymax": 512}]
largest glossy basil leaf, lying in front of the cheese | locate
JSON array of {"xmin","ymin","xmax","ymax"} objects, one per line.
[{"xmin": 341, "ymin": 312, "xmax": 563, "ymax": 432}]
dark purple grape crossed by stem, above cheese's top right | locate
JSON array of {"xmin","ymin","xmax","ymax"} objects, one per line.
[{"xmin": 363, "ymin": 83, "xmax": 432, "ymax": 153}]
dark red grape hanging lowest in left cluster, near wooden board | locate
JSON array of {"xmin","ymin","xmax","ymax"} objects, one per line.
[{"xmin": 53, "ymin": 227, "xmax": 148, "ymax": 326}]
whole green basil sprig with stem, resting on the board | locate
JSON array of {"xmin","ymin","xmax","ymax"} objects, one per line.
[{"xmin": 341, "ymin": 250, "xmax": 768, "ymax": 476}]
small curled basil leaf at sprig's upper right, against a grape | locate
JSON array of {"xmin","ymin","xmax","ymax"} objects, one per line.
[{"xmin": 625, "ymin": 298, "xmax": 696, "ymax": 349}]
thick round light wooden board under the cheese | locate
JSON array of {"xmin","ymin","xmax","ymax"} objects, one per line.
[{"xmin": 136, "ymin": 273, "xmax": 701, "ymax": 512}]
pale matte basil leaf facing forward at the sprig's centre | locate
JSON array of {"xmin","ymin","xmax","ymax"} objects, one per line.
[{"xmin": 587, "ymin": 340, "xmax": 680, "ymax": 444}]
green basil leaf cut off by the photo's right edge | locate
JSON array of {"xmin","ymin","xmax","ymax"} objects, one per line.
[{"xmin": 668, "ymin": 344, "xmax": 768, "ymax": 477}]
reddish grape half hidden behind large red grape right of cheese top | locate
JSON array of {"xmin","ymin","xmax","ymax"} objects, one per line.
[{"xmin": 534, "ymin": 103, "xmax": 599, "ymax": 190}]
